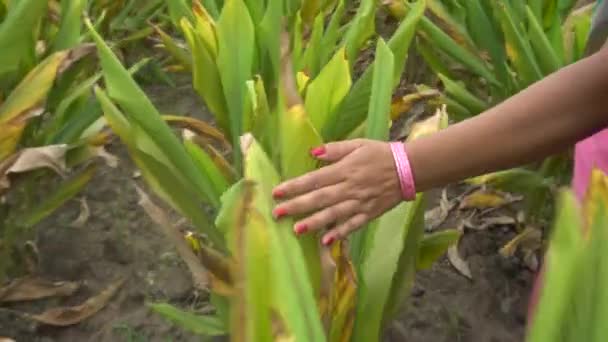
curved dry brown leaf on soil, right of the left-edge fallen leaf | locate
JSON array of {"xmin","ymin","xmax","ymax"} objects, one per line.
[{"xmin": 24, "ymin": 279, "xmax": 125, "ymax": 327}]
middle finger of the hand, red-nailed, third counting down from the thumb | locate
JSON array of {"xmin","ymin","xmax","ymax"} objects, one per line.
[{"xmin": 273, "ymin": 183, "xmax": 347, "ymax": 218}]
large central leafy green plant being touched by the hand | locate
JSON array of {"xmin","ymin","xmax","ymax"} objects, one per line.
[{"xmin": 89, "ymin": 0, "xmax": 458, "ymax": 341}]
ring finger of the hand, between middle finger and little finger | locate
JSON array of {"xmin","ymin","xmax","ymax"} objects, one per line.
[{"xmin": 294, "ymin": 200, "xmax": 360, "ymax": 235}]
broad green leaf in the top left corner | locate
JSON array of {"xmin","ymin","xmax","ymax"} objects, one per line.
[{"xmin": 0, "ymin": 0, "xmax": 47, "ymax": 76}]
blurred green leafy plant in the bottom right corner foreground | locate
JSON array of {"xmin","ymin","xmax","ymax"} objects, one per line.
[{"xmin": 527, "ymin": 170, "xmax": 608, "ymax": 342}]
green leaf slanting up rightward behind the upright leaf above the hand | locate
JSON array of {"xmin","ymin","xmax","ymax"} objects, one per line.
[{"xmin": 322, "ymin": 0, "xmax": 426, "ymax": 141}]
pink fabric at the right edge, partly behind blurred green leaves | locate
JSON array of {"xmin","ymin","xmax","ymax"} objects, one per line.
[{"xmin": 528, "ymin": 129, "xmax": 608, "ymax": 319}]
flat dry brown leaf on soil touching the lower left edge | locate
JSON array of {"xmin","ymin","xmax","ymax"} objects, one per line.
[{"xmin": 0, "ymin": 276, "xmax": 80, "ymax": 303}]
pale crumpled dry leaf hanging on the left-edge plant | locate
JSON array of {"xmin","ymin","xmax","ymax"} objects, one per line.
[{"xmin": 0, "ymin": 144, "xmax": 68, "ymax": 193}]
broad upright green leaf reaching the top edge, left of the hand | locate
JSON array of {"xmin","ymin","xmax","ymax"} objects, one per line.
[{"xmin": 217, "ymin": 0, "xmax": 255, "ymax": 172}]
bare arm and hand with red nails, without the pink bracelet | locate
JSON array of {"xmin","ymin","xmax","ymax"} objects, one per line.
[{"xmin": 274, "ymin": 50, "xmax": 608, "ymax": 244}]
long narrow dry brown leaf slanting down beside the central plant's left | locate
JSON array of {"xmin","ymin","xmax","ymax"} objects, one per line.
[{"xmin": 135, "ymin": 185, "xmax": 209, "ymax": 289}]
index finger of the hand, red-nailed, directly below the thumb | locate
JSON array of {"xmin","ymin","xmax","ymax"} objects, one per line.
[{"xmin": 272, "ymin": 164, "xmax": 344, "ymax": 199}]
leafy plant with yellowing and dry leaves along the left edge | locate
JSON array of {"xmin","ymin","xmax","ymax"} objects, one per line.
[{"xmin": 0, "ymin": 0, "xmax": 119, "ymax": 281}]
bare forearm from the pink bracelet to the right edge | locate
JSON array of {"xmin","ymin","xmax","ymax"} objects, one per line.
[{"xmin": 406, "ymin": 51, "xmax": 608, "ymax": 191}]
